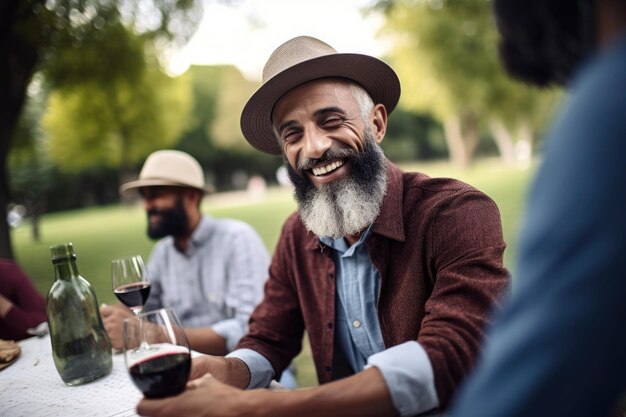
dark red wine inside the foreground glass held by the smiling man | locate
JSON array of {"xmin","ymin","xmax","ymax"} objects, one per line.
[{"xmin": 128, "ymin": 344, "xmax": 191, "ymax": 398}]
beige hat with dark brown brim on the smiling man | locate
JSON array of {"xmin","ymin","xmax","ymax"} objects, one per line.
[{"xmin": 240, "ymin": 36, "xmax": 400, "ymax": 155}]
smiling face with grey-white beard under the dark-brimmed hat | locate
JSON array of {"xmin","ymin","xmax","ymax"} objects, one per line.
[{"xmin": 274, "ymin": 79, "xmax": 387, "ymax": 238}]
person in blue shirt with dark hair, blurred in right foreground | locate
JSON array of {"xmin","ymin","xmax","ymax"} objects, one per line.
[{"xmin": 451, "ymin": 0, "xmax": 626, "ymax": 417}]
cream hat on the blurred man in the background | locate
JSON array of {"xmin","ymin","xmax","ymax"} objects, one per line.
[{"xmin": 120, "ymin": 150, "xmax": 213, "ymax": 192}]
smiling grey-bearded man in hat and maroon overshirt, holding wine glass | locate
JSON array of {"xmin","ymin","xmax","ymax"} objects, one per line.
[{"xmin": 137, "ymin": 36, "xmax": 508, "ymax": 417}]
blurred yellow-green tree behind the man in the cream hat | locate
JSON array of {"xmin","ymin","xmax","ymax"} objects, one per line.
[{"xmin": 43, "ymin": 28, "xmax": 192, "ymax": 182}]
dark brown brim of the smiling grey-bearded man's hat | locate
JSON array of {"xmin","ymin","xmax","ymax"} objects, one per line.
[{"xmin": 240, "ymin": 53, "xmax": 400, "ymax": 155}]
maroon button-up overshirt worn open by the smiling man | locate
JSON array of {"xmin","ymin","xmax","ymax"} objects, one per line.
[{"xmin": 237, "ymin": 163, "xmax": 509, "ymax": 406}]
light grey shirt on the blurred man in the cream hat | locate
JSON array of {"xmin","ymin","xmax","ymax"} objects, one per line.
[{"xmin": 144, "ymin": 215, "xmax": 270, "ymax": 351}]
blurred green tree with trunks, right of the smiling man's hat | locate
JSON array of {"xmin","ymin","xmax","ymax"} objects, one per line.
[{"xmin": 377, "ymin": 0, "xmax": 552, "ymax": 166}]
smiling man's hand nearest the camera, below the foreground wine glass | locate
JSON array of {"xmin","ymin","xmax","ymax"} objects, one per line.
[{"xmin": 137, "ymin": 375, "xmax": 255, "ymax": 417}]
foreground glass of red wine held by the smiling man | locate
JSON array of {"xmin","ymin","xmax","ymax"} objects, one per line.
[{"xmin": 124, "ymin": 308, "xmax": 191, "ymax": 398}]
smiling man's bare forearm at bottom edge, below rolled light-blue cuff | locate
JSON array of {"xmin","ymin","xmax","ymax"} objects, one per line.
[{"xmin": 250, "ymin": 368, "xmax": 397, "ymax": 417}]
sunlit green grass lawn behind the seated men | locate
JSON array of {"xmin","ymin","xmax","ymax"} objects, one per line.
[{"xmin": 11, "ymin": 161, "xmax": 533, "ymax": 386}]
